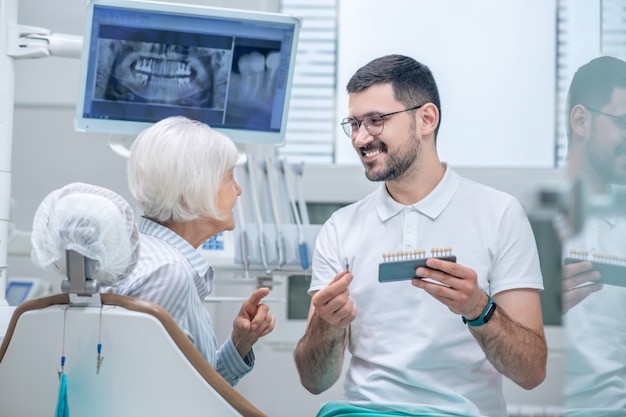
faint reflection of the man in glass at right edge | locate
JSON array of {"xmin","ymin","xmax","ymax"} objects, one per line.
[{"xmin": 562, "ymin": 56, "xmax": 626, "ymax": 416}]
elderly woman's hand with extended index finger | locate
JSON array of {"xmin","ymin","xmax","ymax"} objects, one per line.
[{"xmin": 231, "ymin": 288, "xmax": 274, "ymax": 358}]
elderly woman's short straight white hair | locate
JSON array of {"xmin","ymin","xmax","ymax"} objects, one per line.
[{"xmin": 128, "ymin": 116, "xmax": 238, "ymax": 223}]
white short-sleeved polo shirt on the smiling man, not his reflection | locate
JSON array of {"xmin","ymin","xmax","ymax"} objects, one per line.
[{"xmin": 309, "ymin": 167, "xmax": 543, "ymax": 416}]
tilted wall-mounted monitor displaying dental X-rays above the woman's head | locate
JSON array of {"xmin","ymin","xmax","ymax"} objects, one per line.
[{"xmin": 76, "ymin": 0, "xmax": 301, "ymax": 144}]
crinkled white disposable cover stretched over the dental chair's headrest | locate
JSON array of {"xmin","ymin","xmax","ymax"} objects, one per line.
[{"xmin": 31, "ymin": 182, "xmax": 139, "ymax": 286}]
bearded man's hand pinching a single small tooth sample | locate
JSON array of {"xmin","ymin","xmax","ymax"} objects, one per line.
[{"xmin": 311, "ymin": 271, "xmax": 356, "ymax": 329}]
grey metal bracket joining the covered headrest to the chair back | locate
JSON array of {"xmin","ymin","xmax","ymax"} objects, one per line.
[{"xmin": 61, "ymin": 249, "xmax": 102, "ymax": 307}]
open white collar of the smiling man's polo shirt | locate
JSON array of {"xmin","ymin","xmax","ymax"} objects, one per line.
[{"xmin": 376, "ymin": 164, "xmax": 460, "ymax": 222}]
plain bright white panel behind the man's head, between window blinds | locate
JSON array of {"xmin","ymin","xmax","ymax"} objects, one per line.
[{"xmin": 336, "ymin": 0, "xmax": 556, "ymax": 168}]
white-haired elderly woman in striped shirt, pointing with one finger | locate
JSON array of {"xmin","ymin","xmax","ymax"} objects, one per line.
[{"xmin": 114, "ymin": 117, "xmax": 274, "ymax": 386}]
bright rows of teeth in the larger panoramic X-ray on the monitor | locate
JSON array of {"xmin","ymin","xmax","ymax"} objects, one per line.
[{"xmin": 135, "ymin": 58, "xmax": 191, "ymax": 89}]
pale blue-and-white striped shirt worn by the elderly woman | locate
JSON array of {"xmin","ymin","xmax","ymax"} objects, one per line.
[{"xmin": 113, "ymin": 217, "xmax": 254, "ymax": 386}]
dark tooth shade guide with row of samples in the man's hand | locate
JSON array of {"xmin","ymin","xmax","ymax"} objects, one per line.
[{"xmin": 378, "ymin": 248, "xmax": 456, "ymax": 282}]
